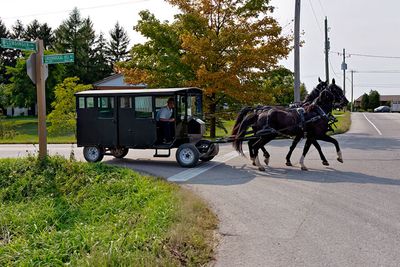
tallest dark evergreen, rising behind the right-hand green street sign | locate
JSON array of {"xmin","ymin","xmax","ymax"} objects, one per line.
[{"xmin": 54, "ymin": 8, "xmax": 96, "ymax": 83}]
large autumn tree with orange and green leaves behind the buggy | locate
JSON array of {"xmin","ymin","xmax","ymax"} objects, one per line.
[{"xmin": 119, "ymin": 0, "xmax": 292, "ymax": 137}]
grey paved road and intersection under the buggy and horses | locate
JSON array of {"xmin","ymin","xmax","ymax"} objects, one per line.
[{"xmin": 0, "ymin": 113, "xmax": 400, "ymax": 266}]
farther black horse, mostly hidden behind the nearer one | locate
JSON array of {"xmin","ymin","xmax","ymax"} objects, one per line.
[{"xmin": 232, "ymin": 78, "xmax": 334, "ymax": 169}]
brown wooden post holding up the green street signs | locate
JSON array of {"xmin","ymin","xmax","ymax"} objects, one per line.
[{"xmin": 36, "ymin": 39, "xmax": 47, "ymax": 159}]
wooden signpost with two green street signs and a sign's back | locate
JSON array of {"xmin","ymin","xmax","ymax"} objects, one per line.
[{"xmin": 0, "ymin": 38, "xmax": 74, "ymax": 159}]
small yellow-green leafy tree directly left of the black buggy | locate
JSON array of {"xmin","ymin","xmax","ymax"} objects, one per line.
[{"xmin": 48, "ymin": 77, "xmax": 92, "ymax": 134}]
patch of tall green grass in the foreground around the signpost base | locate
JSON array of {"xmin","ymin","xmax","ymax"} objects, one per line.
[{"xmin": 0, "ymin": 156, "xmax": 217, "ymax": 266}]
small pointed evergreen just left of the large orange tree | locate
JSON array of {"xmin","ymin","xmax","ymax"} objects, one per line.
[{"xmin": 107, "ymin": 22, "xmax": 129, "ymax": 64}]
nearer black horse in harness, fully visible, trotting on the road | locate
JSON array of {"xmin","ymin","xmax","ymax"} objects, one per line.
[{"xmin": 233, "ymin": 80, "xmax": 348, "ymax": 170}]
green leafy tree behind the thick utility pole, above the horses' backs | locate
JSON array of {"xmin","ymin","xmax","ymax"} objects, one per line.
[{"xmin": 264, "ymin": 67, "xmax": 307, "ymax": 106}]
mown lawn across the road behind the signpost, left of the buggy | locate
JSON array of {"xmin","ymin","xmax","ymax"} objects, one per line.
[{"xmin": 0, "ymin": 117, "xmax": 76, "ymax": 144}]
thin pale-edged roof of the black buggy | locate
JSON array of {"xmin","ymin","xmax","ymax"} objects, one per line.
[{"xmin": 75, "ymin": 87, "xmax": 202, "ymax": 96}]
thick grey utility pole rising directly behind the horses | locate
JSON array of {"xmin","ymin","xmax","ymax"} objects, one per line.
[{"xmin": 294, "ymin": 0, "xmax": 301, "ymax": 103}]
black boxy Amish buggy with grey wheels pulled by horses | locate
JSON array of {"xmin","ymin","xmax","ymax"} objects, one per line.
[{"xmin": 75, "ymin": 88, "xmax": 219, "ymax": 167}]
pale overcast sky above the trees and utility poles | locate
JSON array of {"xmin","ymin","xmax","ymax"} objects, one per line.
[{"xmin": 0, "ymin": 0, "xmax": 400, "ymax": 100}]
